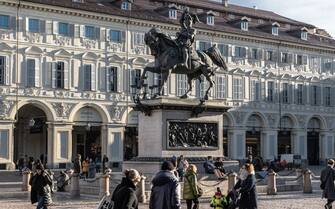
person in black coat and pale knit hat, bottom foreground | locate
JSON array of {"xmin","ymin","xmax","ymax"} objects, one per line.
[{"xmin": 112, "ymin": 169, "xmax": 141, "ymax": 209}]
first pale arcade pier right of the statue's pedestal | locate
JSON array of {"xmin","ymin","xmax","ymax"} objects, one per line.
[{"xmin": 228, "ymin": 129, "xmax": 246, "ymax": 160}]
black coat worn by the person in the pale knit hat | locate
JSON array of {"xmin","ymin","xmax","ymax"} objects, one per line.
[{"xmin": 112, "ymin": 178, "xmax": 138, "ymax": 209}]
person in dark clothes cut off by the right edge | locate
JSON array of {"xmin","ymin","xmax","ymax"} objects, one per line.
[{"xmin": 320, "ymin": 159, "xmax": 335, "ymax": 209}]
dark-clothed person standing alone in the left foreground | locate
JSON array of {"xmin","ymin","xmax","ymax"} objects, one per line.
[{"xmin": 29, "ymin": 164, "xmax": 52, "ymax": 209}]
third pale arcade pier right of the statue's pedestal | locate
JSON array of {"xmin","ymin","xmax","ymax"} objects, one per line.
[{"xmin": 292, "ymin": 129, "xmax": 307, "ymax": 160}]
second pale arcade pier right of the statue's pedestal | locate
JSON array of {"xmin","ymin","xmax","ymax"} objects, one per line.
[{"xmin": 261, "ymin": 130, "xmax": 278, "ymax": 160}]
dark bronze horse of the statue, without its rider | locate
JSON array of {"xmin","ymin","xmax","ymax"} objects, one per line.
[{"xmin": 140, "ymin": 28, "xmax": 227, "ymax": 100}]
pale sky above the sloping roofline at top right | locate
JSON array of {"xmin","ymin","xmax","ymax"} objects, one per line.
[{"xmin": 229, "ymin": 0, "xmax": 335, "ymax": 37}]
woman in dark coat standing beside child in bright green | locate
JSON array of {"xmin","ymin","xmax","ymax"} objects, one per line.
[{"xmin": 234, "ymin": 163, "xmax": 257, "ymax": 209}]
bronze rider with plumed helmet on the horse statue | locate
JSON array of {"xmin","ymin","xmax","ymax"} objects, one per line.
[{"xmin": 176, "ymin": 7, "xmax": 200, "ymax": 68}]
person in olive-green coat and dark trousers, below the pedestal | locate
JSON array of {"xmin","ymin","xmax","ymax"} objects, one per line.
[{"xmin": 183, "ymin": 164, "xmax": 201, "ymax": 209}]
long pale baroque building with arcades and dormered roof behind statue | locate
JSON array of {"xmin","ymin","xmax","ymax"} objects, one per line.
[{"xmin": 0, "ymin": 0, "xmax": 335, "ymax": 169}]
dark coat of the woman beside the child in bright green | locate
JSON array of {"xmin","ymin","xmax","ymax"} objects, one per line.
[{"xmin": 234, "ymin": 174, "xmax": 257, "ymax": 209}]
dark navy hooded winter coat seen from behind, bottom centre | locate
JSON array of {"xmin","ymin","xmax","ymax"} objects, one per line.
[{"xmin": 149, "ymin": 171, "xmax": 181, "ymax": 209}]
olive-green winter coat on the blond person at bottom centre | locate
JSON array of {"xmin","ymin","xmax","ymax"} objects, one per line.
[{"xmin": 183, "ymin": 170, "xmax": 199, "ymax": 200}]
